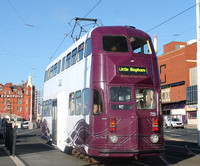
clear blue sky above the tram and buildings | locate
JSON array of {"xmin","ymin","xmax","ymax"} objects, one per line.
[{"xmin": 0, "ymin": 0, "xmax": 196, "ymax": 89}]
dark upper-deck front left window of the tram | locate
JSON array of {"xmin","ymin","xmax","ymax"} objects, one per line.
[{"xmin": 102, "ymin": 36, "xmax": 128, "ymax": 52}]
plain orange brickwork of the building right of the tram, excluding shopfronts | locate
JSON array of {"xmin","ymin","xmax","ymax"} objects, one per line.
[{"xmin": 158, "ymin": 42, "xmax": 196, "ymax": 102}]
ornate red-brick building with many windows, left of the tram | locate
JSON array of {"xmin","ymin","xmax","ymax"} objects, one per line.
[{"xmin": 0, "ymin": 83, "xmax": 35, "ymax": 121}]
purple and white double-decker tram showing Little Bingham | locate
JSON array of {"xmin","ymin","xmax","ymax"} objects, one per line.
[{"xmin": 42, "ymin": 26, "xmax": 164, "ymax": 157}]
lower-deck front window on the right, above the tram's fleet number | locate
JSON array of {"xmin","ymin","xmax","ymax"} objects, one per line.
[{"xmin": 135, "ymin": 89, "xmax": 156, "ymax": 110}]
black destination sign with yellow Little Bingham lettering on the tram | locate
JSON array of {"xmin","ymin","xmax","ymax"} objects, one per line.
[{"xmin": 118, "ymin": 66, "xmax": 148, "ymax": 75}]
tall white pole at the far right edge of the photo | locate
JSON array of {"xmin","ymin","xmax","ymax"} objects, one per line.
[{"xmin": 196, "ymin": 0, "xmax": 200, "ymax": 146}]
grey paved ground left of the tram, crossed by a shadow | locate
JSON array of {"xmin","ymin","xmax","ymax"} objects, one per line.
[{"xmin": 0, "ymin": 129, "xmax": 86, "ymax": 166}]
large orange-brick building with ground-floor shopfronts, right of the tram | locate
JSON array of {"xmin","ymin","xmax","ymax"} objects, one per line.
[{"xmin": 158, "ymin": 40, "xmax": 197, "ymax": 124}]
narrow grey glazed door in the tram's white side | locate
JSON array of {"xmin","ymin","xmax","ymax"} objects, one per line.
[{"xmin": 52, "ymin": 99, "xmax": 57, "ymax": 144}]
